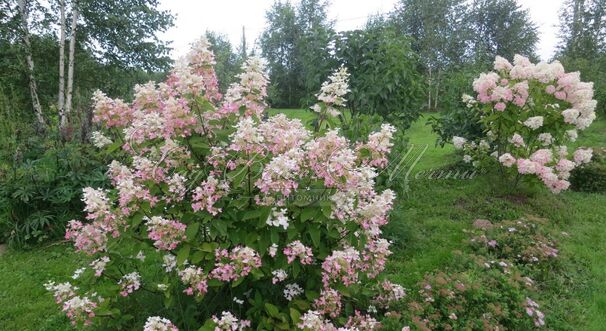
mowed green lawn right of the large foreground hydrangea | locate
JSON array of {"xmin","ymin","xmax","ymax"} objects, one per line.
[{"xmin": 386, "ymin": 116, "xmax": 606, "ymax": 330}]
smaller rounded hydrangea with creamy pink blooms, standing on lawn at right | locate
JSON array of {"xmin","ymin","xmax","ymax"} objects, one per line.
[{"xmin": 452, "ymin": 55, "xmax": 597, "ymax": 193}]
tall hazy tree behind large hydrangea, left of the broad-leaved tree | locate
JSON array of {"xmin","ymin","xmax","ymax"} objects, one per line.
[{"xmin": 260, "ymin": 0, "xmax": 334, "ymax": 108}]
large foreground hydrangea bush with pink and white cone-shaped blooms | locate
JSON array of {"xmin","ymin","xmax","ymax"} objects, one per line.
[{"xmin": 46, "ymin": 39, "xmax": 403, "ymax": 331}]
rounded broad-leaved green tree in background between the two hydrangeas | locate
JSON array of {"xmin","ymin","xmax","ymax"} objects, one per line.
[{"xmin": 335, "ymin": 27, "xmax": 424, "ymax": 129}]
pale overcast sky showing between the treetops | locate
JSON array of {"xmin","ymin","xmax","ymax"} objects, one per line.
[{"xmin": 161, "ymin": 0, "xmax": 563, "ymax": 60}]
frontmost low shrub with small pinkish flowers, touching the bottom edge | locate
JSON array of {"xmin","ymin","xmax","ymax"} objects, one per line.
[{"xmin": 390, "ymin": 266, "xmax": 545, "ymax": 331}]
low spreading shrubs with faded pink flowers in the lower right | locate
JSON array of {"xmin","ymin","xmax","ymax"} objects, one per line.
[{"xmin": 384, "ymin": 219, "xmax": 559, "ymax": 330}]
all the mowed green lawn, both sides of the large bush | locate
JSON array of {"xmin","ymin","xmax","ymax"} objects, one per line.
[{"xmin": 0, "ymin": 109, "xmax": 606, "ymax": 330}]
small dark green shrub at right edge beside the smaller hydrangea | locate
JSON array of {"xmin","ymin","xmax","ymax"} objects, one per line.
[{"xmin": 570, "ymin": 148, "xmax": 606, "ymax": 193}]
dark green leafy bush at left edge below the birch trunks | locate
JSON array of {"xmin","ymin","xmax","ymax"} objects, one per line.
[{"xmin": 0, "ymin": 138, "xmax": 106, "ymax": 247}]
